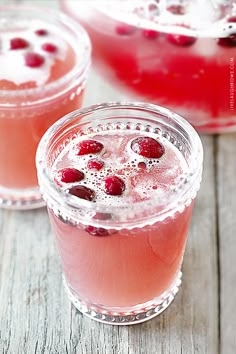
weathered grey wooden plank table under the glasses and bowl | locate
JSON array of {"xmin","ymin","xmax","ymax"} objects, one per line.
[{"xmin": 0, "ymin": 1, "xmax": 236, "ymax": 354}]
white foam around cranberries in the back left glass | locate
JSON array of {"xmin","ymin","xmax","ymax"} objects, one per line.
[{"xmin": 0, "ymin": 20, "xmax": 68, "ymax": 86}]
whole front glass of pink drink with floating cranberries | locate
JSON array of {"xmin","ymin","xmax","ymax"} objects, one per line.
[{"xmin": 36, "ymin": 103, "xmax": 203, "ymax": 324}]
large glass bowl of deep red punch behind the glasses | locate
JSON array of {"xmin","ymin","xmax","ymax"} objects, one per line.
[{"xmin": 60, "ymin": 0, "xmax": 236, "ymax": 133}]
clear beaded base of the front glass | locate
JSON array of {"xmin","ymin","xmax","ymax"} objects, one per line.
[{"xmin": 63, "ymin": 272, "xmax": 182, "ymax": 325}]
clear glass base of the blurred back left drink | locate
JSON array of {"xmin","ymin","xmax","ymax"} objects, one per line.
[{"xmin": 0, "ymin": 186, "xmax": 45, "ymax": 210}]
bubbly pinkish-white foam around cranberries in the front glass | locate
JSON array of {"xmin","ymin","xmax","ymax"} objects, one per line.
[{"xmin": 52, "ymin": 130, "xmax": 189, "ymax": 207}]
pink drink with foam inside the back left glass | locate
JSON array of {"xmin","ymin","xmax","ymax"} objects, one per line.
[{"xmin": 0, "ymin": 21, "xmax": 87, "ymax": 189}]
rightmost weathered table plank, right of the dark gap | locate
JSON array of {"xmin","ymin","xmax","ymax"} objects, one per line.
[{"xmin": 217, "ymin": 134, "xmax": 236, "ymax": 353}]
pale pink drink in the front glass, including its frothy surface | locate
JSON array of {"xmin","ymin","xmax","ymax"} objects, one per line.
[{"xmin": 49, "ymin": 131, "xmax": 193, "ymax": 308}]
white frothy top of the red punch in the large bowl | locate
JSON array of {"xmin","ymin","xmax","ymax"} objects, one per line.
[{"xmin": 71, "ymin": 0, "xmax": 236, "ymax": 38}]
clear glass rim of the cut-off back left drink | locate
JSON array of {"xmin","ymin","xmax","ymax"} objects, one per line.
[{"xmin": 0, "ymin": 4, "xmax": 92, "ymax": 102}]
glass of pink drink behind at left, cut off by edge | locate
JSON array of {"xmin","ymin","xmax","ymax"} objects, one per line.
[{"xmin": 0, "ymin": 6, "xmax": 91, "ymax": 209}]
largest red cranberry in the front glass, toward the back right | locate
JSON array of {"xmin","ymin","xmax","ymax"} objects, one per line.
[{"xmin": 131, "ymin": 136, "xmax": 165, "ymax": 159}]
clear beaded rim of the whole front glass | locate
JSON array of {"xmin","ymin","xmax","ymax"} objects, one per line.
[{"xmin": 36, "ymin": 101, "xmax": 203, "ymax": 224}]
